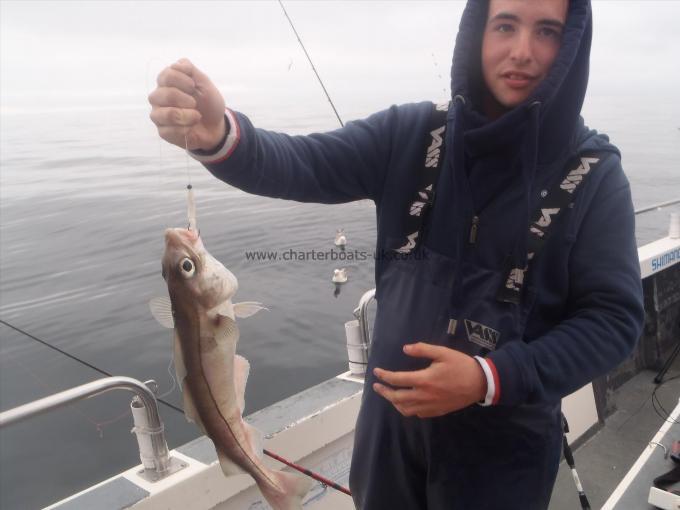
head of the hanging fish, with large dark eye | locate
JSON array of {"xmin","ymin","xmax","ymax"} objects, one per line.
[{"xmin": 162, "ymin": 228, "xmax": 238, "ymax": 309}]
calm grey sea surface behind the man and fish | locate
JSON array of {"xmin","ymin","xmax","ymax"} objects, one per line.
[{"xmin": 0, "ymin": 98, "xmax": 680, "ymax": 510}]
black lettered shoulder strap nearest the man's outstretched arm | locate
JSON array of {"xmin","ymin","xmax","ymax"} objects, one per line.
[{"xmin": 395, "ymin": 103, "xmax": 449, "ymax": 253}]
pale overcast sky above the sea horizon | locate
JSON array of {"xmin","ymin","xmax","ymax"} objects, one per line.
[{"xmin": 0, "ymin": 0, "xmax": 680, "ymax": 120}]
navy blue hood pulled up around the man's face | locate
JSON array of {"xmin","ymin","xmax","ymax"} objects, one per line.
[{"xmin": 451, "ymin": 0, "xmax": 592, "ymax": 163}]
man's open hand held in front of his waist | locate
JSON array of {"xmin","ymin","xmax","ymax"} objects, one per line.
[{"xmin": 373, "ymin": 342, "xmax": 487, "ymax": 418}]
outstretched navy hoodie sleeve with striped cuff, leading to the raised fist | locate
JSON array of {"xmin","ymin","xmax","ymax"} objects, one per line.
[{"xmin": 197, "ymin": 107, "xmax": 397, "ymax": 203}]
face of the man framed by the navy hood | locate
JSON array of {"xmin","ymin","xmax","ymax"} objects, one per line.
[{"xmin": 482, "ymin": 0, "xmax": 569, "ymax": 117}]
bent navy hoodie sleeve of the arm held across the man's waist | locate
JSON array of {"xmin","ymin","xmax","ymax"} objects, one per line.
[{"xmin": 487, "ymin": 157, "xmax": 644, "ymax": 405}]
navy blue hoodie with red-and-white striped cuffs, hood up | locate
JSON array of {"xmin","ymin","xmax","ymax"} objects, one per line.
[{"xmin": 203, "ymin": 0, "xmax": 644, "ymax": 405}]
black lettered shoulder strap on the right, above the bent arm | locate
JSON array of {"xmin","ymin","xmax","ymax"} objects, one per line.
[{"xmin": 496, "ymin": 151, "xmax": 609, "ymax": 304}]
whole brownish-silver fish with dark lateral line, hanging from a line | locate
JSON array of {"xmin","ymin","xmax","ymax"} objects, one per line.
[{"xmin": 150, "ymin": 228, "xmax": 312, "ymax": 510}]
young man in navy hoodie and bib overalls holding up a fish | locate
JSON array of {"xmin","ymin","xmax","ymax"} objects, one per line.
[{"xmin": 150, "ymin": 0, "xmax": 643, "ymax": 510}]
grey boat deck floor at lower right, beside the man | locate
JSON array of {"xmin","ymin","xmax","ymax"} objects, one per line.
[{"xmin": 549, "ymin": 352, "xmax": 680, "ymax": 510}]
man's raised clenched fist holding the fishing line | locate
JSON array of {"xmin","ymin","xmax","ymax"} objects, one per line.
[{"xmin": 149, "ymin": 58, "xmax": 226, "ymax": 151}]
